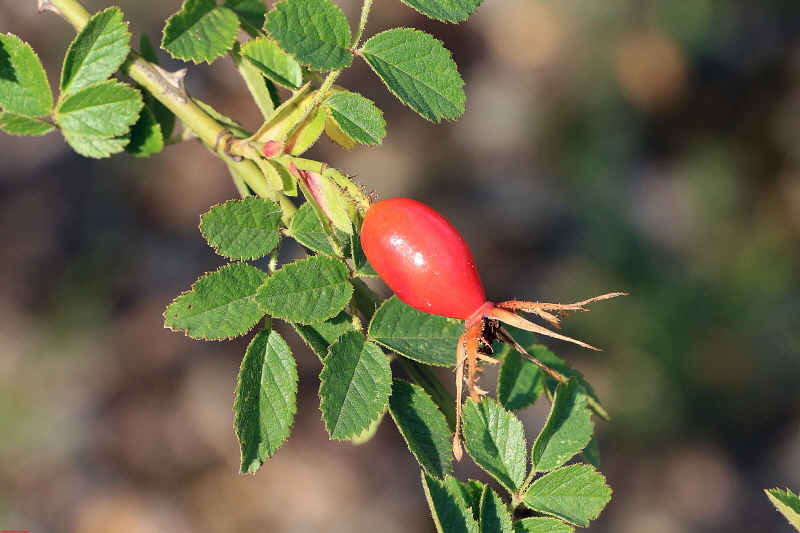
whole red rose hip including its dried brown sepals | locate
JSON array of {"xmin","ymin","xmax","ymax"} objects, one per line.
[{"xmin": 361, "ymin": 198, "xmax": 626, "ymax": 459}]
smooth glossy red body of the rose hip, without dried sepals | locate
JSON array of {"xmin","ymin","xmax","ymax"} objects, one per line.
[{"xmin": 361, "ymin": 198, "xmax": 486, "ymax": 320}]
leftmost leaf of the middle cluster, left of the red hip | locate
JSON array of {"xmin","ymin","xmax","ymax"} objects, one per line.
[{"xmin": 164, "ymin": 263, "xmax": 267, "ymax": 339}]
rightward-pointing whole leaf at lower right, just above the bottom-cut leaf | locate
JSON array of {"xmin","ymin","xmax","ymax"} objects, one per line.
[{"xmin": 522, "ymin": 464, "xmax": 611, "ymax": 527}]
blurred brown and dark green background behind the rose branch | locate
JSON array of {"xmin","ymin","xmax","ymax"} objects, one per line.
[{"xmin": 0, "ymin": 0, "xmax": 800, "ymax": 533}]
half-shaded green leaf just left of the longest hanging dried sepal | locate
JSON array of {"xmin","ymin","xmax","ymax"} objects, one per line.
[{"xmin": 389, "ymin": 379, "xmax": 453, "ymax": 479}]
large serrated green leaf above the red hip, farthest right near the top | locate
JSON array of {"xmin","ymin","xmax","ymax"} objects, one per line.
[{"xmin": 361, "ymin": 28, "xmax": 466, "ymax": 122}]
